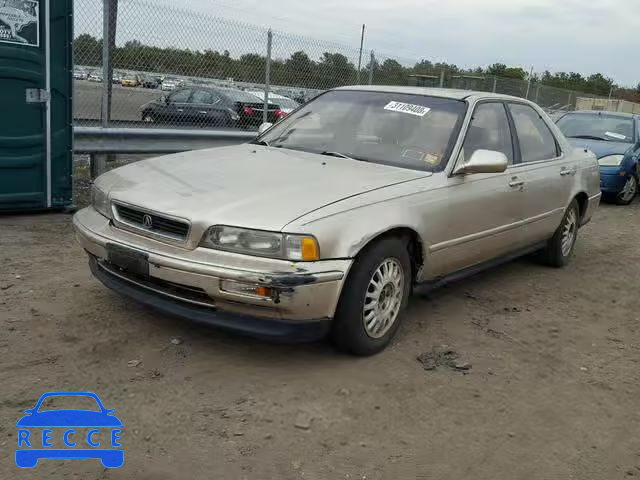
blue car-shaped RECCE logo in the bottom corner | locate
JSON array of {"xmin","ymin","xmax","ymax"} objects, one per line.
[{"xmin": 16, "ymin": 392, "xmax": 124, "ymax": 468}]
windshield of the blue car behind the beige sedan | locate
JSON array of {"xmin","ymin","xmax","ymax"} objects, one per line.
[{"xmin": 557, "ymin": 113, "xmax": 633, "ymax": 143}]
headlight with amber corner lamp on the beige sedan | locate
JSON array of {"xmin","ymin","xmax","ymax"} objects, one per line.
[{"xmin": 200, "ymin": 225, "xmax": 320, "ymax": 262}]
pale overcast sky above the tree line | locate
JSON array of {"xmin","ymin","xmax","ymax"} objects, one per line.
[{"xmin": 76, "ymin": 0, "xmax": 640, "ymax": 86}]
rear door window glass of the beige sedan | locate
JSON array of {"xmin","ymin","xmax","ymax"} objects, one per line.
[{"xmin": 509, "ymin": 103, "xmax": 558, "ymax": 163}]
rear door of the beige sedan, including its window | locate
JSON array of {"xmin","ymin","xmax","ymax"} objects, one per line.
[{"xmin": 508, "ymin": 102, "xmax": 578, "ymax": 243}]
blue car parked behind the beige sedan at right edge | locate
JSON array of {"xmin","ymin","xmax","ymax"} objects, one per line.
[{"xmin": 556, "ymin": 111, "xmax": 640, "ymax": 205}]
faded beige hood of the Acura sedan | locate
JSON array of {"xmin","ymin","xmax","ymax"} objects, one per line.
[{"xmin": 96, "ymin": 144, "xmax": 431, "ymax": 231}]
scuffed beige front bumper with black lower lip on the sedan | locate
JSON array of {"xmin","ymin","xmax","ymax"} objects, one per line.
[{"xmin": 73, "ymin": 207, "xmax": 352, "ymax": 340}]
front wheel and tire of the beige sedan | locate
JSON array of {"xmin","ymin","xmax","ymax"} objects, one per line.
[{"xmin": 331, "ymin": 237, "xmax": 412, "ymax": 356}]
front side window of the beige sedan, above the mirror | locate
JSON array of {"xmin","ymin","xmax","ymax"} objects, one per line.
[{"xmin": 462, "ymin": 103, "xmax": 513, "ymax": 165}]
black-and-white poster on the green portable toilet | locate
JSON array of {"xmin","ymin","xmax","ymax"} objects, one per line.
[{"xmin": 0, "ymin": 0, "xmax": 40, "ymax": 47}]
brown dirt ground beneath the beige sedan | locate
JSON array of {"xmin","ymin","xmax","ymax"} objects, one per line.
[{"xmin": 0, "ymin": 202, "xmax": 640, "ymax": 480}]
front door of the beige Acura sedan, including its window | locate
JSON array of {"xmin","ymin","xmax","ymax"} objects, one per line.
[{"xmin": 429, "ymin": 101, "xmax": 524, "ymax": 277}]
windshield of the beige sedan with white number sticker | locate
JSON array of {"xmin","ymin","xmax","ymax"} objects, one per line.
[{"xmin": 259, "ymin": 90, "xmax": 466, "ymax": 171}]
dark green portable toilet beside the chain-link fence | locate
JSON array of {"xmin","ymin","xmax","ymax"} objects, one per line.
[{"xmin": 0, "ymin": 0, "xmax": 73, "ymax": 212}]
